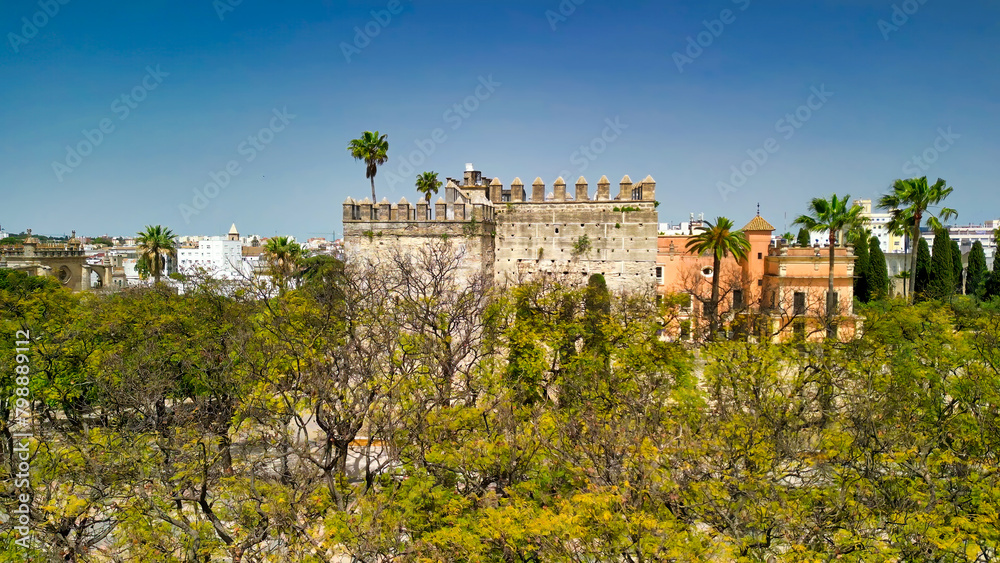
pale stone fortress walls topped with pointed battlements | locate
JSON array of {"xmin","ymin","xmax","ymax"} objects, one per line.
[{"xmin": 343, "ymin": 167, "xmax": 658, "ymax": 291}]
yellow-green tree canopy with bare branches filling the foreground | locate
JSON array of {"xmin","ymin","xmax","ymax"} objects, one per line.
[{"xmin": 0, "ymin": 259, "xmax": 1000, "ymax": 562}]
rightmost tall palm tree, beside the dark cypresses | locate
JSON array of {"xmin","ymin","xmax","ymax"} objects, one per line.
[{"xmin": 878, "ymin": 176, "xmax": 958, "ymax": 298}]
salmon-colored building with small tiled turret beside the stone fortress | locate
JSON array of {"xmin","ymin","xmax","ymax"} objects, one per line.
[{"xmin": 656, "ymin": 215, "xmax": 857, "ymax": 341}]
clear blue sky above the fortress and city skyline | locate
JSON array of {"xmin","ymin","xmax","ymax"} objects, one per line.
[{"xmin": 0, "ymin": 0, "xmax": 1000, "ymax": 238}]
